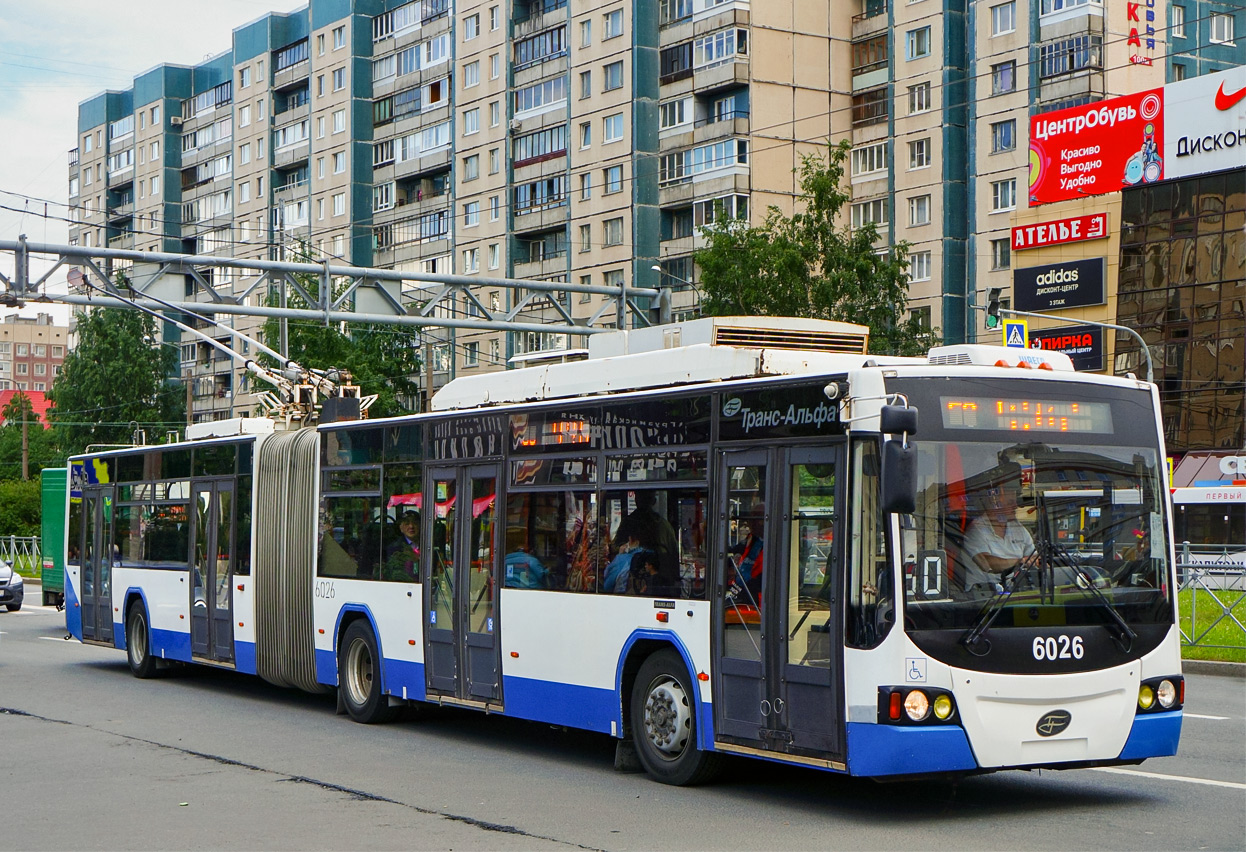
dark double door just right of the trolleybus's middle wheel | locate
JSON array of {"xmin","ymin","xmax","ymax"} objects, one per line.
[{"xmin": 422, "ymin": 465, "xmax": 502, "ymax": 705}]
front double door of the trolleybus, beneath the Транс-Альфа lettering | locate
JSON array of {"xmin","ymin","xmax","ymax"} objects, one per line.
[{"xmin": 714, "ymin": 447, "xmax": 842, "ymax": 759}]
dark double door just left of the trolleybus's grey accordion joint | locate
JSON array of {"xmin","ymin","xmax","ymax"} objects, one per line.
[{"xmin": 191, "ymin": 482, "xmax": 234, "ymax": 663}]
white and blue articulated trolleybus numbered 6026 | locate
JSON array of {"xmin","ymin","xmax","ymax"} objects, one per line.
[{"xmin": 66, "ymin": 318, "xmax": 1184, "ymax": 783}]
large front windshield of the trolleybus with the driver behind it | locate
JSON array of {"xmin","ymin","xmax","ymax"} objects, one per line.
[{"xmin": 901, "ymin": 438, "xmax": 1172, "ymax": 633}]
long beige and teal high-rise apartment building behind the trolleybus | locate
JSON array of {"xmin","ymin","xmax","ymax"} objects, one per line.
[{"xmin": 70, "ymin": 0, "xmax": 1246, "ymax": 438}]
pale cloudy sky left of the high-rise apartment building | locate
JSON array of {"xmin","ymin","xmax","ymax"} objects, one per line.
[{"xmin": 0, "ymin": 0, "xmax": 303, "ymax": 323}]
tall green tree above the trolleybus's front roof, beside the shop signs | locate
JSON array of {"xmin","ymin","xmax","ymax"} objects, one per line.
[{"xmin": 694, "ymin": 141, "xmax": 936, "ymax": 355}]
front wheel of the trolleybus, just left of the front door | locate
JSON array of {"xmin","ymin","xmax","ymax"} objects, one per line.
[{"xmin": 632, "ymin": 649, "xmax": 718, "ymax": 787}]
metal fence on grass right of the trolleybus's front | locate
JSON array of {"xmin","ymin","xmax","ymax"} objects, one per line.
[{"xmin": 1176, "ymin": 542, "xmax": 1246, "ymax": 649}]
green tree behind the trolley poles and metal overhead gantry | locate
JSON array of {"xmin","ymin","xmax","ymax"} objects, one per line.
[{"xmin": 264, "ymin": 257, "xmax": 420, "ymax": 417}]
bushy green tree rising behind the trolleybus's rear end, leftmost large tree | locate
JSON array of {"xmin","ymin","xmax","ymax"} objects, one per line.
[{"xmin": 47, "ymin": 308, "xmax": 186, "ymax": 455}]
